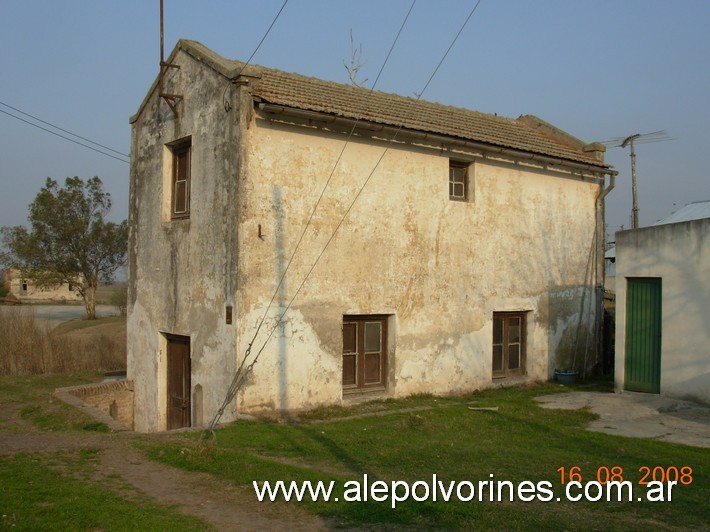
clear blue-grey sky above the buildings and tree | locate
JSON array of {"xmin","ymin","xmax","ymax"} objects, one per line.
[{"xmin": 0, "ymin": 0, "xmax": 710, "ymax": 240}]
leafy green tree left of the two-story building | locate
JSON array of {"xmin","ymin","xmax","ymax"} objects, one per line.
[{"xmin": 0, "ymin": 177, "xmax": 128, "ymax": 320}]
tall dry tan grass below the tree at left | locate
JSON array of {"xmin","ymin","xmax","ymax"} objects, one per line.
[{"xmin": 0, "ymin": 308, "xmax": 126, "ymax": 375}]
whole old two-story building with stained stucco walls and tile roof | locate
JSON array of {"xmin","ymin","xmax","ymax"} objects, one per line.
[{"xmin": 128, "ymin": 40, "xmax": 615, "ymax": 431}]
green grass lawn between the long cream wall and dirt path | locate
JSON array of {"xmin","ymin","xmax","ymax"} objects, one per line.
[{"xmin": 146, "ymin": 384, "xmax": 710, "ymax": 530}]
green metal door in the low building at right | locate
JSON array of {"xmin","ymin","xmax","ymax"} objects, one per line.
[{"xmin": 624, "ymin": 277, "xmax": 661, "ymax": 393}]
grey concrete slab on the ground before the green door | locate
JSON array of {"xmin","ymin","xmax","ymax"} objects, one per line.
[{"xmin": 535, "ymin": 392, "xmax": 710, "ymax": 448}]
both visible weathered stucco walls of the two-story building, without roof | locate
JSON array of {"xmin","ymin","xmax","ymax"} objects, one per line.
[{"xmin": 128, "ymin": 49, "xmax": 600, "ymax": 431}]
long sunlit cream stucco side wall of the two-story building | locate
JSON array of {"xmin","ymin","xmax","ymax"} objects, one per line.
[{"xmin": 238, "ymin": 114, "xmax": 599, "ymax": 410}]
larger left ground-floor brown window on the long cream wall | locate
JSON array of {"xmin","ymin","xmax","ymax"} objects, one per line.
[{"xmin": 343, "ymin": 316, "xmax": 387, "ymax": 392}]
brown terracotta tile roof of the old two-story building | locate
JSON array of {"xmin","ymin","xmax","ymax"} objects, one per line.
[{"xmin": 180, "ymin": 41, "xmax": 609, "ymax": 168}]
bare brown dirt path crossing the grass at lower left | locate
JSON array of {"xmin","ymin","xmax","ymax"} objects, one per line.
[{"xmin": 0, "ymin": 404, "xmax": 328, "ymax": 531}]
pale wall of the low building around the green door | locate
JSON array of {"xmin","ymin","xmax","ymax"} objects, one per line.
[{"xmin": 615, "ymin": 218, "xmax": 710, "ymax": 403}]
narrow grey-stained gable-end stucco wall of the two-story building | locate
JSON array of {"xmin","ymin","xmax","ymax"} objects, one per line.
[{"xmin": 128, "ymin": 48, "xmax": 246, "ymax": 431}]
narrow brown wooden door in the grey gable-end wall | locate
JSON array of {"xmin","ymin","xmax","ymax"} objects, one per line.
[{"xmin": 168, "ymin": 336, "xmax": 192, "ymax": 430}]
